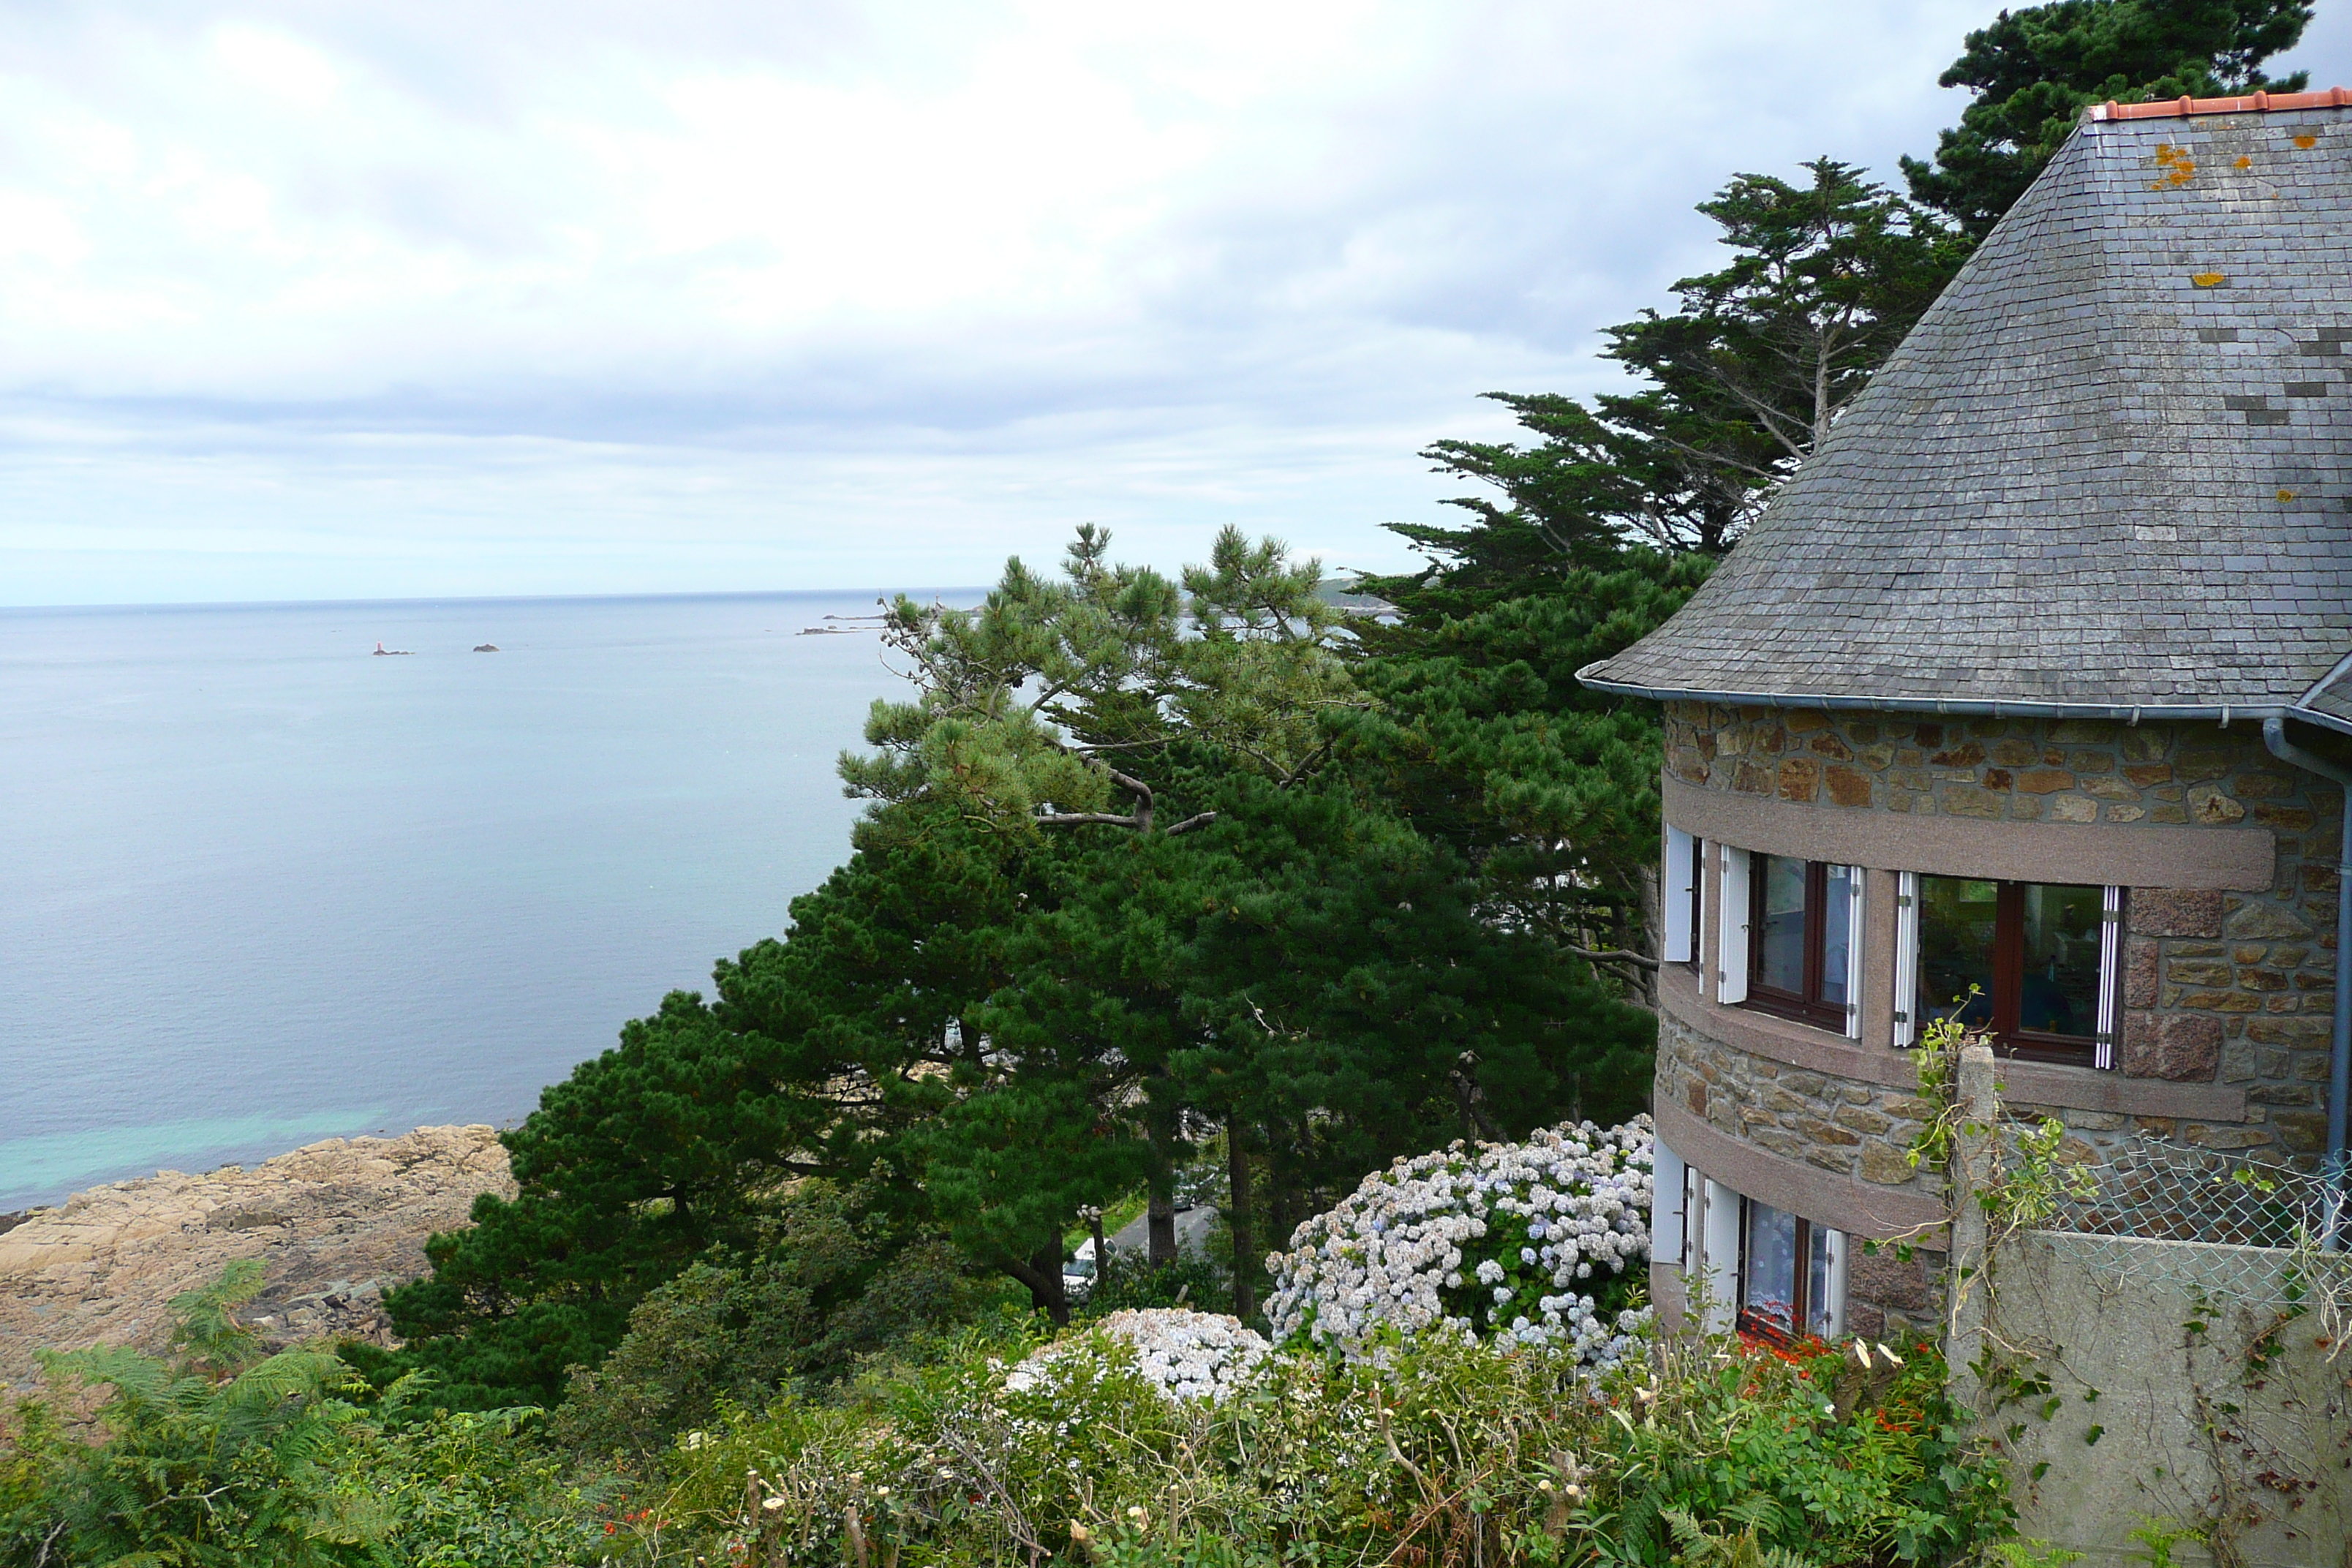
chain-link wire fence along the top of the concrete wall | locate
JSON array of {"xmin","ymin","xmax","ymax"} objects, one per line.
[{"xmin": 2039, "ymin": 1140, "xmax": 2352, "ymax": 1309}]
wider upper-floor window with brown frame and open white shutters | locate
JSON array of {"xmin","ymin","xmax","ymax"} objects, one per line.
[{"xmin": 1917, "ymin": 877, "xmax": 2122, "ymax": 1067}]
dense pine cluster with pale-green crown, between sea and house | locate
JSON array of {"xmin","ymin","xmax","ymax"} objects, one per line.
[{"xmin": 388, "ymin": 517, "xmax": 1656, "ymax": 1401}]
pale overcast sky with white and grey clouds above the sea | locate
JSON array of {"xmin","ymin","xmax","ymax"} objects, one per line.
[{"xmin": 0, "ymin": 0, "xmax": 2352, "ymax": 604}]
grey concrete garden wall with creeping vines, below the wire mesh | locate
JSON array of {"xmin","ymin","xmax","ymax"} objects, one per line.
[{"xmin": 1954, "ymin": 1232, "xmax": 2352, "ymax": 1568}]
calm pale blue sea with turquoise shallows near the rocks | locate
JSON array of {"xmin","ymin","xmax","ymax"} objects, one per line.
[{"xmin": 0, "ymin": 595, "xmax": 954, "ymax": 1210}]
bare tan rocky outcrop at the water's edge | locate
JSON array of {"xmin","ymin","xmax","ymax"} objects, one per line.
[{"xmin": 0, "ymin": 1126, "xmax": 515, "ymax": 1392}]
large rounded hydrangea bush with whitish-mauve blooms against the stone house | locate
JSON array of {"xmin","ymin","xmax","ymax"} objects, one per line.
[{"xmin": 1265, "ymin": 1117, "xmax": 1651, "ymax": 1366}]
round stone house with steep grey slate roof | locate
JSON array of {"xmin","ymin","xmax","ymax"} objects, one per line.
[{"xmin": 1580, "ymin": 89, "xmax": 2352, "ymax": 1333}]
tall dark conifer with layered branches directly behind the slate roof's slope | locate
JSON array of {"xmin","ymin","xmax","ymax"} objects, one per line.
[{"xmin": 1331, "ymin": 157, "xmax": 1969, "ymax": 992}]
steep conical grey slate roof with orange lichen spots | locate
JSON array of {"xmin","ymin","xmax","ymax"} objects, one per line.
[{"xmin": 1583, "ymin": 89, "xmax": 2352, "ymax": 728}]
